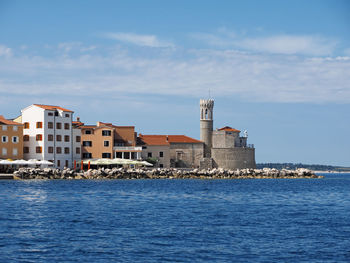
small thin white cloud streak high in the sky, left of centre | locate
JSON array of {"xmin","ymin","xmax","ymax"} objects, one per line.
[{"xmin": 104, "ymin": 32, "xmax": 174, "ymax": 47}]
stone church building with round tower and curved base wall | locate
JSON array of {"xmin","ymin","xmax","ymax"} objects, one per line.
[{"xmin": 200, "ymin": 99, "xmax": 256, "ymax": 169}]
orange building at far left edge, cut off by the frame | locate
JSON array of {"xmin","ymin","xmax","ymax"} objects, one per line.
[{"xmin": 0, "ymin": 115, "xmax": 23, "ymax": 159}]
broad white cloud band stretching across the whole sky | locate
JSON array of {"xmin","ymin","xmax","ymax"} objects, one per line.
[{"xmin": 0, "ymin": 44, "xmax": 350, "ymax": 103}]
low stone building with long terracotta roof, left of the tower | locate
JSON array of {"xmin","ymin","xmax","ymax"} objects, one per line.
[{"xmin": 139, "ymin": 134, "xmax": 204, "ymax": 168}]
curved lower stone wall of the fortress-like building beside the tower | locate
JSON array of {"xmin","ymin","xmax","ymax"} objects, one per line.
[{"xmin": 211, "ymin": 147, "xmax": 256, "ymax": 169}]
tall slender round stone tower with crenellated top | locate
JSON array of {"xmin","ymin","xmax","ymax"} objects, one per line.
[{"xmin": 199, "ymin": 99, "xmax": 214, "ymax": 158}]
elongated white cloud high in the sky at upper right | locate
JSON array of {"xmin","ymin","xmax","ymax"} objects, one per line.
[{"xmin": 191, "ymin": 28, "xmax": 337, "ymax": 56}]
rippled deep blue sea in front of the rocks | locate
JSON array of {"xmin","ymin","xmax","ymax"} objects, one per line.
[{"xmin": 0, "ymin": 174, "xmax": 350, "ymax": 263}]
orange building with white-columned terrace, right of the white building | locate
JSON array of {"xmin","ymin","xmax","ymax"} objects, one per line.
[{"xmin": 76, "ymin": 119, "xmax": 142, "ymax": 160}]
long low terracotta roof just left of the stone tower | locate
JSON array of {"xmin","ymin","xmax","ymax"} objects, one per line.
[{"xmin": 139, "ymin": 134, "xmax": 202, "ymax": 145}]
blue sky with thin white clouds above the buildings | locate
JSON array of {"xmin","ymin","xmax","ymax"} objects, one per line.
[{"xmin": 0, "ymin": 0, "xmax": 350, "ymax": 166}]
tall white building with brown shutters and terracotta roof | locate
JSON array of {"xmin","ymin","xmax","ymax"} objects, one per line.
[{"xmin": 21, "ymin": 104, "xmax": 81, "ymax": 169}]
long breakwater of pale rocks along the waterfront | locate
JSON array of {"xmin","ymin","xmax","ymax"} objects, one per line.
[{"xmin": 13, "ymin": 168, "xmax": 323, "ymax": 179}]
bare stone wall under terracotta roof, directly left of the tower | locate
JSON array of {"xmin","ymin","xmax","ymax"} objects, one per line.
[{"xmin": 170, "ymin": 143, "xmax": 204, "ymax": 168}]
